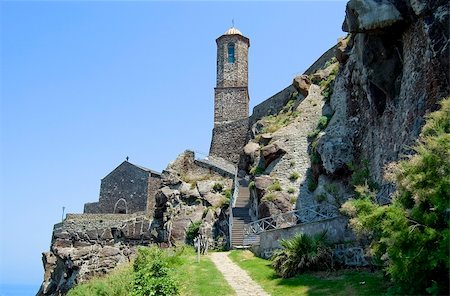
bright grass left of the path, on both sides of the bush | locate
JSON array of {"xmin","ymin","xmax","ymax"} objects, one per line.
[{"xmin": 67, "ymin": 247, "xmax": 236, "ymax": 296}]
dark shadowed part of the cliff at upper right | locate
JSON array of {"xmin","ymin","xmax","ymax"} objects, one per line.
[{"xmin": 317, "ymin": 0, "xmax": 449, "ymax": 192}]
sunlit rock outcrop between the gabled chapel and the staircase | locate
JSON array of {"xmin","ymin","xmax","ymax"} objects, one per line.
[{"xmin": 151, "ymin": 151, "xmax": 234, "ymax": 248}]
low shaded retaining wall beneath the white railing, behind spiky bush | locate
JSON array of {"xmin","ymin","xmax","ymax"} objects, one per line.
[{"xmin": 257, "ymin": 216, "xmax": 355, "ymax": 258}]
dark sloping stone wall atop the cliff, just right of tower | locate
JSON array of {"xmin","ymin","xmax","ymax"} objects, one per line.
[{"xmin": 250, "ymin": 85, "xmax": 301, "ymax": 124}]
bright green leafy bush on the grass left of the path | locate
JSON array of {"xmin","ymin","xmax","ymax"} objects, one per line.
[{"xmin": 131, "ymin": 247, "xmax": 179, "ymax": 296}]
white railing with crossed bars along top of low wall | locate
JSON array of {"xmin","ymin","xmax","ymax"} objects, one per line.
[{"xmin": 244, "ymin": 205, "xmax": 338, "ymax": 236}]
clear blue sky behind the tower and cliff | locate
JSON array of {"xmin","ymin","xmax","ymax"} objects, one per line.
[{"xmin": 0, "ymin": 1, "xmax": 346, "ymax": 286}]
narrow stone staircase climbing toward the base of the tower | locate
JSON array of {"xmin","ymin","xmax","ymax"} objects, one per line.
[{"xmin": 231, "ymin": 179, "xmax": 252, "ymax": 248}]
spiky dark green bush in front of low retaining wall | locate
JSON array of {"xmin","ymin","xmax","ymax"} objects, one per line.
[{"xmin": 272, "ymin": 232, "xmax": 333, "ymax": 278}]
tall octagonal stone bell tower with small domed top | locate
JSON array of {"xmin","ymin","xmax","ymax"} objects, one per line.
[{"xmin": 209, "ymin": 27, "xmax": 250, "ymax": 164}]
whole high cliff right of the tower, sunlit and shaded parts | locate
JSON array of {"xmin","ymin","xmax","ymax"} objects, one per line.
[{"xmin": 241, "ymin": 0, "xmax": 449, "ymax": 222}]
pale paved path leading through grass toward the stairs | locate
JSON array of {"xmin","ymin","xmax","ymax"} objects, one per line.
[{"xmin": 210, "ymin": 252, "xmax": 269, "ymax": 296}]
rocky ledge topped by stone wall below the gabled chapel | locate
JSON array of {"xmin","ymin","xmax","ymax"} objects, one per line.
[{"xmin": 37, "ymin": 214, "xmax": 151, "ymax": 295}]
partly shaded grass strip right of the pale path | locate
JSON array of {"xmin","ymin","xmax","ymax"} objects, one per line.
[{"xmin": 230, "ymin": 250, "xmax": 387, "ymax": 296}]
